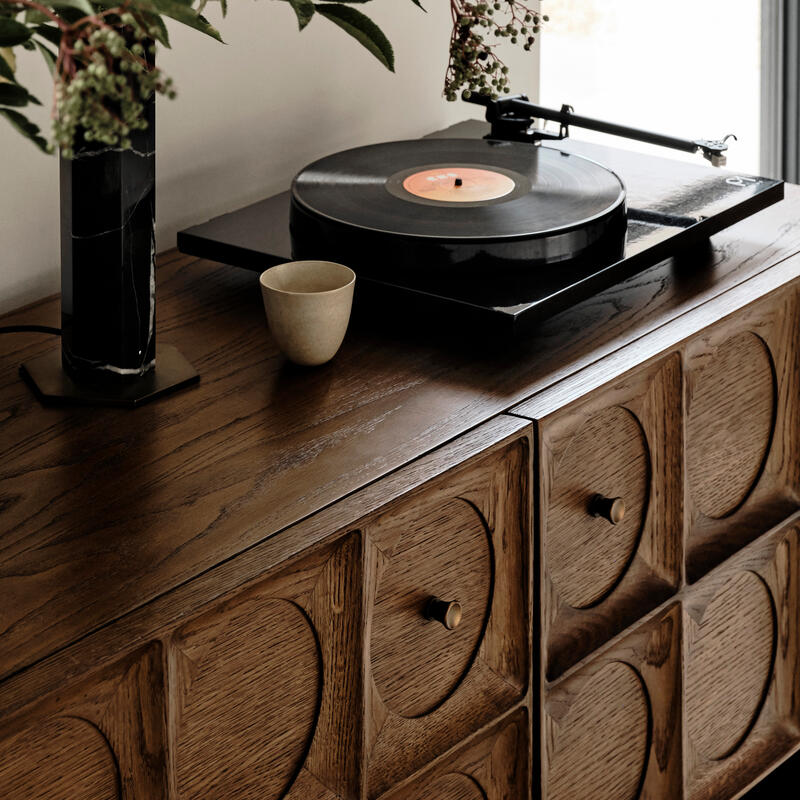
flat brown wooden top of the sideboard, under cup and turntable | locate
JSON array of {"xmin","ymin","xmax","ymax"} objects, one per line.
[{"xmin": 0, "ymin": 172, "xmax": 800, "ymax": 677}]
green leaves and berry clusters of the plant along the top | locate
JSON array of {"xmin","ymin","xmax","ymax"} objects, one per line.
[{"xmin": 0, "ymin": 0, "xmax": 546, "ymax": 157}]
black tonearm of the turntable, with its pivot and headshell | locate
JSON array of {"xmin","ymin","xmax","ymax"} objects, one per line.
[{"xmin": 463, "ymin": 93, "xmax": 736, "ymax": 167}]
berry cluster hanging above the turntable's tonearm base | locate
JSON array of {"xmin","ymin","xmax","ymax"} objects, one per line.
[{"xmin": 444, "ymin": 0, "xmax": 548, "ymax": 101}]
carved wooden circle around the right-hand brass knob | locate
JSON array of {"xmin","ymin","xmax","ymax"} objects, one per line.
[{"xmin": 545, "ymin": 406, "xmax": 650, "ymax": 608}]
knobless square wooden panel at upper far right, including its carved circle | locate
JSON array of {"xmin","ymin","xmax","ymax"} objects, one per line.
[{"xmin": 685, "ymin": 290, "xmax": 800, "ymax": 582}]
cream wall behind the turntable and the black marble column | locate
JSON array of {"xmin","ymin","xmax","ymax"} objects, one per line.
[{"xmin": 0, "ymin": 0, "xmax": 538, "ymax": 312}]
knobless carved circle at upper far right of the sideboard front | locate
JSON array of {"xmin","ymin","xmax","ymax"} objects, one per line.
[{"xmin": 686, "ymin": 333, "xmax": 775, "ymax": 519}]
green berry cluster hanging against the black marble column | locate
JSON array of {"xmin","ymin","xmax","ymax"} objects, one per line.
[{"xmin": 53, "ymin": 7, "xmax": 175, "ymax": 158}]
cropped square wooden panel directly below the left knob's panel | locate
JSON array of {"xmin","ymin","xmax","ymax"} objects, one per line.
[{"xmin": 383, "ymin": 711, "xmax": 530, "ymax": 800}]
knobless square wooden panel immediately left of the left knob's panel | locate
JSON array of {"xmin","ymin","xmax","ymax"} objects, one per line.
[{"xmin": 169, "ymin": 535, "xmax": 362, "ymax": 800}]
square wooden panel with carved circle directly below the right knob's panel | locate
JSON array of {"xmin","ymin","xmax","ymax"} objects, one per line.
[{"xmin": 541, "ymin": 604, "xmax": 682, "ymax": 800}]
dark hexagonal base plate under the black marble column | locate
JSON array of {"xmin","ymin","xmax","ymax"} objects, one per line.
[{"xmin": 19, "ymin": 345, "xmax": 200, "ymax": 408}]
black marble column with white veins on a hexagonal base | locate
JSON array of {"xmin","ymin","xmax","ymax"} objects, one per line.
[{"xmin": 61, "ymin": 101, "xmax": 155, "ymax": 380}]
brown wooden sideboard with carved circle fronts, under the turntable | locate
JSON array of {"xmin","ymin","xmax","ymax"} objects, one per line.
[{"xmin": 0, "ymin": 187, "xmax": 800, "ymax": 800}]
